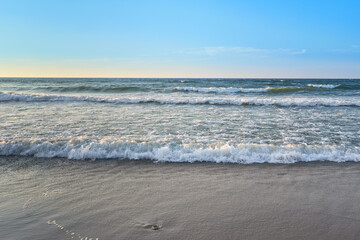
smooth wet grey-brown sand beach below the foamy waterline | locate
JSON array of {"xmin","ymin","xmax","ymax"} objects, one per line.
[{"xmin": 0, "ymin": 157, "xmax": 360, "ymax": 240}]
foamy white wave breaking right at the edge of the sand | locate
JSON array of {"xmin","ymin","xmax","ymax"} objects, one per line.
[{"xmin": 0, "ymin": 139, "xmax": 360, "ymax": 164}]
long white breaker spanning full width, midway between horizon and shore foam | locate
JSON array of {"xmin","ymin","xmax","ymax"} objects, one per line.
[{"xmin": 0, "ymin": 92, "xmax": 360, "ymax": 107}]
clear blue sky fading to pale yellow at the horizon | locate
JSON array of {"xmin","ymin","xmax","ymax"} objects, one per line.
[{"xmin": 0, "ymin": 0, "xmax": 360, "ymax": 78}]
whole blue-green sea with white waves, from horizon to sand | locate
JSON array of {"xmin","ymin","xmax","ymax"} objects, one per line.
[{"xmin": 0, "ymin": 78, "xmax": 360, "ymax": 164}]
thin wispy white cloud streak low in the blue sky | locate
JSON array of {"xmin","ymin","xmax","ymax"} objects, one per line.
[{"xmin": 177, "ymin": 46, "xmax": 306, "ymax": 56}]
